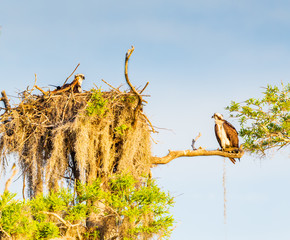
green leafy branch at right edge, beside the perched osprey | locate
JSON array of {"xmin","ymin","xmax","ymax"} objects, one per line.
[{"xmin": 226, "ymin": 84, "xmax": 290, "ymax": 155}]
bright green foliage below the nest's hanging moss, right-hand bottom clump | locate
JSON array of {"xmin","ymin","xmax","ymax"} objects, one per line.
[{"xmin": 78, "ymin": 175, "xmax": 174, "ymax": 239}]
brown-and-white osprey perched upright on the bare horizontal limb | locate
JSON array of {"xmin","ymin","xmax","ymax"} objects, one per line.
[{"xmin": 212, "ymin": 113, "xmax": 239, "ymax": 164}]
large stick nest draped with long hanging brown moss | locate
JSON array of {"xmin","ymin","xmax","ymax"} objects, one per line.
[{"xmin": 0, "ymin": 90, "xmax": 151, "ymax": 196}]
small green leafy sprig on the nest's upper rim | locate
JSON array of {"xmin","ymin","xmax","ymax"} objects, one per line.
[{"xmin": 86, "ymin": 89, "xmax": 108, "ymax": 116}]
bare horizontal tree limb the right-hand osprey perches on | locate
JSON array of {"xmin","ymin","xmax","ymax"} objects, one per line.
[{"xmin": 151, "ymin": 148, "xmax": 244, "ymax": 164}]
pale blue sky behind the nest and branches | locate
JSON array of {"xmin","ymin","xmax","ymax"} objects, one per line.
[{"xmin": 0, "ymin": 0, "xmax": 290, "ymax": 240}]
